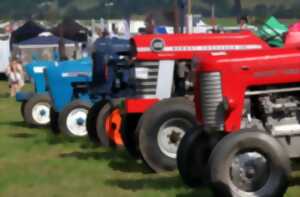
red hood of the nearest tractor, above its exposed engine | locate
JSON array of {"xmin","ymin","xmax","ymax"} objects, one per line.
[{"xmin": 195, "ymin": 48, "xmax": 300, "ymax": 81}]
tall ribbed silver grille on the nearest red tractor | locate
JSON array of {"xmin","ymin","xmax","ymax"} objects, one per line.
[{"xmin": 200, "ymin": 72, "xmax": 224, "ymax": 130}]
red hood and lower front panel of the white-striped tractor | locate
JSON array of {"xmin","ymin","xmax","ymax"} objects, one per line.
[{"xmin": 125, "ymin": 31, "xmax": 269, "ymax": 113}]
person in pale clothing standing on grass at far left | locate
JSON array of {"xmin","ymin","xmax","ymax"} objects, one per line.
[{"xmin": 6, "ymin": 58, "xmax": 25, "ymax": 97}]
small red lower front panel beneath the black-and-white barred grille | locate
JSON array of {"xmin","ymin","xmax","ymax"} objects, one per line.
[{"xmin": 125, "ymin": 99, "xmax": 159, "ymax": 114}]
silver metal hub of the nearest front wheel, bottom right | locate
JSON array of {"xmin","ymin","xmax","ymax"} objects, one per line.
[{"xmin": 230, "ymin": 152, "xmax": 270, "ymax": 192}]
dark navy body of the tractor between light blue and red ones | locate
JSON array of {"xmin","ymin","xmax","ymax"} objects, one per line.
[{"xmin": 89, "ymin": 38, "xmax": 131, "ymax": 100}]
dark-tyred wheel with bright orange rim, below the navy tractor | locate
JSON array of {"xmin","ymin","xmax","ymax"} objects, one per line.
[{"xmin": 96, "ymin": 100, "xmax": 123, "ymax": 147}]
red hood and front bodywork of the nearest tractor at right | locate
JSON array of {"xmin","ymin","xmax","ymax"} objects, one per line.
[{"xmin": 195, "ymin": 49, "xmax": 300, "ymax": 132}]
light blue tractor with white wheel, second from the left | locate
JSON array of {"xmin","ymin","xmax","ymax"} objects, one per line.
[{"xmin": 45, "ymin": 58, "xmax": 92, "ymax": 136}]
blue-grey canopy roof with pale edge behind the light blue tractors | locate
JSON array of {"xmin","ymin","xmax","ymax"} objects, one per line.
[{"xmin": 18, "ymin": 35, "xmax": 75, "ymax": 48}]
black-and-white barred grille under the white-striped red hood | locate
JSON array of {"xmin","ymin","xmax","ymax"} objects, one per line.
[{"xmin": 135, "ymin": 62, "xmax": 159, "ymax": 98}]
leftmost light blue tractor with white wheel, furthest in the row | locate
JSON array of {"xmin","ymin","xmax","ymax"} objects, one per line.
[{"xmin": 16, "ymin": 60, "xmax": 55, "ymax": 126}]
